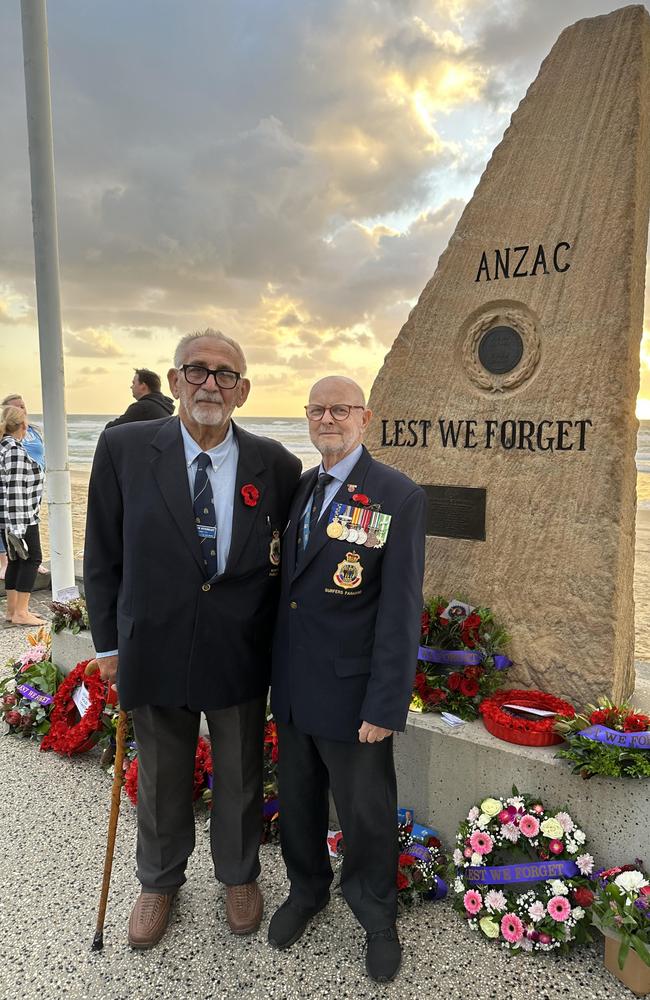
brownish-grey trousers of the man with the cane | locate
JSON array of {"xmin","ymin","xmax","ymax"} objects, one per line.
[{"xmin": 133, "ymin": 697, "xmax": 266, "ymax": 893}]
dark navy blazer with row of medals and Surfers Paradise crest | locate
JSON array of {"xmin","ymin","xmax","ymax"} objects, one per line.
[{"xmin": 271, "ymin": 448, "xmax": 426, "ymax": 741}]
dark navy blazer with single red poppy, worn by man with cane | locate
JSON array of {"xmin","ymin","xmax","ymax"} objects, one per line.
[{"xmin": 84, "ymin": 417, "xmax": 301, "ymax": 710}]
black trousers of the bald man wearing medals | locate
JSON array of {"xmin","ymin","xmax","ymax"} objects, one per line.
[{"xmin": 278, "ymin": 723, "xmax": 398, "ymax": 933}]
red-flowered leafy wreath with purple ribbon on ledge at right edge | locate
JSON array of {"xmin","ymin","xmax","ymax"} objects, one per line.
[{"xmin": 555, "ymin": 697, "xmax": 650, "ymax": 778}]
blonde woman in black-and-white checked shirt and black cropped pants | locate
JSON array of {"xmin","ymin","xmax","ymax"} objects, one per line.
[{"xmin": 0, "ymin": 406, "xmax": 45, "ymax": 625}]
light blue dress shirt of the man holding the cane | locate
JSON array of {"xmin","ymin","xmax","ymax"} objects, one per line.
[{"xmin": 96, "ymin": 420, "xmax": 238, "ymax": 660}]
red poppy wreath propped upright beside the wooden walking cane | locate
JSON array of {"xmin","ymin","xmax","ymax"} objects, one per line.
[{"xmin": 41, "ymin": 660, "xmax": 108, "ymax": 757}]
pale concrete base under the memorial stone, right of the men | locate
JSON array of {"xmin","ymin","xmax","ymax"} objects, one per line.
[{"xmin": 395, "ymin": 692, "xmax": 648, "ymax": 866}]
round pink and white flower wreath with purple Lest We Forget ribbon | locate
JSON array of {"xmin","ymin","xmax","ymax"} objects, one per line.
[{"xmin": 453, "ymin": 788, "xmax": 594, "ymax": 951}]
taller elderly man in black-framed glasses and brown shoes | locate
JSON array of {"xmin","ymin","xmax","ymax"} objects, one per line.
[{"xmin": 84, "ymin": 330, "xmax": 300, "ymax": 949}]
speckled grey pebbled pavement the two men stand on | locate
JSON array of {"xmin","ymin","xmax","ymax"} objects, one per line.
[{"xmin": 0, "ymin": 602, "xmax": 631, "ymax": 1000}]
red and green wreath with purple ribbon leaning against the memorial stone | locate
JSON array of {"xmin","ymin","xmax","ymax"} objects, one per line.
[{"xmin": 411, "ymin": 597, "xmax": 511, "ymax": 719}]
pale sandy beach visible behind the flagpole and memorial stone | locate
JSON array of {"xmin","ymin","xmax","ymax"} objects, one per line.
[{"xmin": 31, "ymin": 469, "xmax": 650, "ymax": 661}]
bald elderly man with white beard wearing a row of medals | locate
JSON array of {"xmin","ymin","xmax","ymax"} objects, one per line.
[{"xmin": 268, "ymin": 376, "xmax": 425, "ymax": 982}]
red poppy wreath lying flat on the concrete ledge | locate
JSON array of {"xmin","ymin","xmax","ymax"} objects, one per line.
[{"xmin": 479, "ymin": 688, "xmax": 575, "ymax": 747}]
